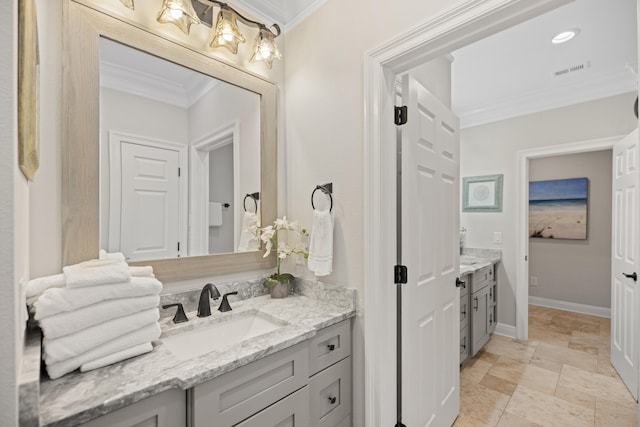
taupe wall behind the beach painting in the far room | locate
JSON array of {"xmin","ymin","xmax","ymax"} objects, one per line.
[{"xmin": 529, "ymin": 150, "xmax": 612, "ymax": 308}]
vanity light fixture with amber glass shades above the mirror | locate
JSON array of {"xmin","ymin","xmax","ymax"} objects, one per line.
[{"xmin": 149, "ymin": 0, "xmax": 282, "ymax": 68}]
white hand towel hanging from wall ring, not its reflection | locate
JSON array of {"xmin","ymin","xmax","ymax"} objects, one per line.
[{"xmin": 307, "ymin": 210, "xmax": 333, "ymax": 276}]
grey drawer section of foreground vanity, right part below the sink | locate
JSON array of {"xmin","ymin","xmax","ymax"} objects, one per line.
[{"xmin": 192, "ymin": 320, "xmax": 351, "ymax": 427}]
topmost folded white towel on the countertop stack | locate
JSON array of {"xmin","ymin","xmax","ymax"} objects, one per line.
[{"xmin": 62, "ymin": 259, "xmax": 131, "ymax": 288}]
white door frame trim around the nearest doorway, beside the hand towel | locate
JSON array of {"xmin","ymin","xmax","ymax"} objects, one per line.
[{"xmin": 364, "ymin": 0, "xmax": 571, "ymax": 427}]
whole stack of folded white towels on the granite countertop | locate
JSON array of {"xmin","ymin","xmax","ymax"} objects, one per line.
[{"xmin": 25, "ymin": 251, "xmax": 162, "ymax": 379}]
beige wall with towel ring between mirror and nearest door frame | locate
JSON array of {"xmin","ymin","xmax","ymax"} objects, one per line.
[{"xmin": 285, "ymin": 0, "xmax": 463, "ymax": 426}]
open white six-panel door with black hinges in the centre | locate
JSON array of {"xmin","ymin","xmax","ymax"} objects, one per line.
[{"xmin": 400, "ymin": 75, "xmax": 460, "ymax": 426}]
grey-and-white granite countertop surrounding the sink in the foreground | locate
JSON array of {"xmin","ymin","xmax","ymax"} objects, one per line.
[{"xmin": 39, "ymin": 287, "xmax": 356, "ymax": 426}]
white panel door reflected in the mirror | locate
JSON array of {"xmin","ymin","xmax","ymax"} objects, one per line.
[{"xmin": 120, "ymin": 143, "xmax": 180, "ymax": 261}]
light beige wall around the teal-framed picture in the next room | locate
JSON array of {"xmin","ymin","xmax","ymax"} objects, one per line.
[{"xmin": 460, "ymin": 93, "xmax": 637, "ymax": 326}]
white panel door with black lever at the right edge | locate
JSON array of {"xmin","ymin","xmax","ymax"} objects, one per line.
[{"xmin": 611, "ymin": 130, "xmax": 640, "ymax": 399}]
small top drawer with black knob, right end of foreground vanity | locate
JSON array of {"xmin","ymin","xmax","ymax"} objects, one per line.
[{"xmin": 309, "ymin": 320, "xmax": 351, "ymax": 375}]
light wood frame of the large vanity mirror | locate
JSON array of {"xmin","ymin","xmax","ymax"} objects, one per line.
[{"xmin": 62, "ymin": 0, "xmax": 277, "ymax": 281}]
